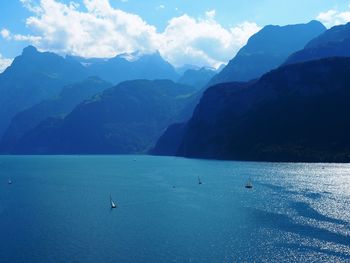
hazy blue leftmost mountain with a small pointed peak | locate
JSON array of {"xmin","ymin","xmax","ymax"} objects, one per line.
[{"xmin": 0, "ymin": 46, "xmax": 89, "ymax": 137}]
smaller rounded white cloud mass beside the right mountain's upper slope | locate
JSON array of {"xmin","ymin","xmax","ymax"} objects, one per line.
[{"xmin": 160, "ymin": 13, "xmax": 260, "ymax": 66}]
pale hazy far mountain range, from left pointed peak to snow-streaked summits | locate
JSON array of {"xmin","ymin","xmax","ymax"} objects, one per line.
[{"xmin": 0, "ymin": 46, "xmax": 189, "ymax": 140}]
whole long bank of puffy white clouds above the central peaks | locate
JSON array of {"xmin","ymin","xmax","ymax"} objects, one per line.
[{"xmin": 8, "ymin": 0, "xmax": 260, "ymax": 66}]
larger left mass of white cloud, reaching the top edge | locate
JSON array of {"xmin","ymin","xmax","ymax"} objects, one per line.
[{"xmin": 17, "ymin": 0, "xmax": 157, "ymax": 57}]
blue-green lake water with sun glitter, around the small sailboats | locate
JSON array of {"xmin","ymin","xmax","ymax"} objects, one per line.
[{"xmin": 0, "ymin": 156, "xmax": 350, "ymax": 263}]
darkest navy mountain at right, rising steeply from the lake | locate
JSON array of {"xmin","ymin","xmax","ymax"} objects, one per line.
[{"xmin": 155, "ymin": 58, "xmax": 350, "ymax": 162}]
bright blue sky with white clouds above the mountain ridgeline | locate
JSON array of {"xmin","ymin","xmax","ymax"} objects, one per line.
[{"xmin": 0, "ymin": 0, "xmax": 350, "ymax": 72}]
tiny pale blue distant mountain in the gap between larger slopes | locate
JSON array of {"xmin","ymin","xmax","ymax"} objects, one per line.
[{"xmin": 178, "ymin": 68, "xmax": 216, "ymax": 90}]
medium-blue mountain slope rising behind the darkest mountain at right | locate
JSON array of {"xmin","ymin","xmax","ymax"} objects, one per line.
[{"xmin": 208, "ymin": 21, "xmax": 326, "ymax": 87}]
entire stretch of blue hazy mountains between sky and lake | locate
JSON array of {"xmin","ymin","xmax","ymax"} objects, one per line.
[{"xmin": 0, "ymin": 21, "xmax": 350, "ymax": 161}]
